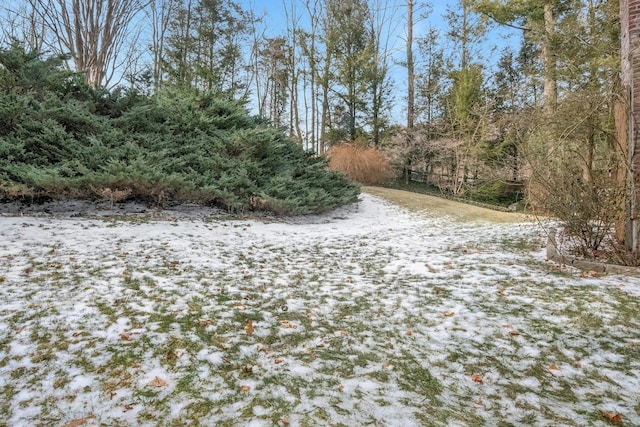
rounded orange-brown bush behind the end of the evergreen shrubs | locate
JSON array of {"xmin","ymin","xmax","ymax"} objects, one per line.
[{"xmin": 327, "ymin": 144, "xmax": 393, "ymax": 185}]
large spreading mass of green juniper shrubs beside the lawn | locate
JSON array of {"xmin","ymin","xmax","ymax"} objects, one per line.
[{"xmin": 0, "ymin": 46, "xmax": 359, "ymax": 214}]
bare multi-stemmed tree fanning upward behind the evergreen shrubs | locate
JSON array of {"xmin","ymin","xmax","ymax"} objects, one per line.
[{"xmin": 29, "ymin": 0, "xmax": 149, "ymax": 87}]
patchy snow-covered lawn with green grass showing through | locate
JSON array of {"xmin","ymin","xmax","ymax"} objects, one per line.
[{"xmin": 0, "ymin": 194, "xmax": 640, "ymax": 426}]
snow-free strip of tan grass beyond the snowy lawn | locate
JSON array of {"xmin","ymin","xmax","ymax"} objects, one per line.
[{"xmin": 362, "ymin": 187, "xmax": 534, "ymax": 223}]
